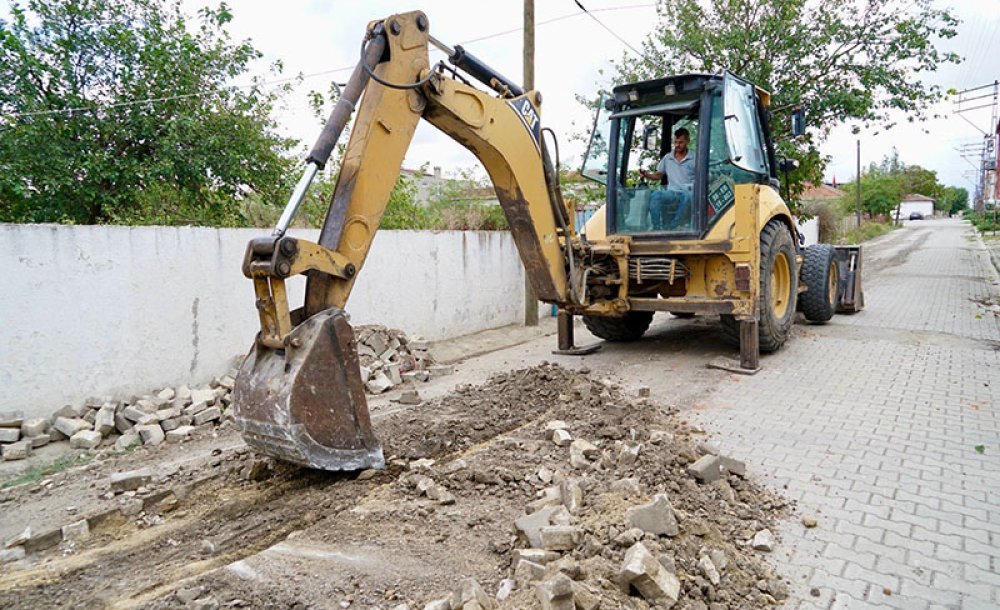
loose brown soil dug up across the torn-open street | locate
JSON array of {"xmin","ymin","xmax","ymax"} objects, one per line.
[{"xmin": 0, "ymin": 364, "xmax": 790, "ymax": 610}]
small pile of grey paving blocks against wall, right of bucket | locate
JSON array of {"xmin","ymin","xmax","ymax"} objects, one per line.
[{"xmin": 354, "ymin": 324, "xmax": 451, "ymax": 394}]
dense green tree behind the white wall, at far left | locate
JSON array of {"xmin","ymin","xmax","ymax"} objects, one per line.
[{"xmin": 0, "ymin": 0, "xmax": 291, "ymax": 225}]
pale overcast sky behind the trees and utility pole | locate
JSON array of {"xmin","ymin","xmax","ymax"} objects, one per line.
[{"xmin": 197, "ymin": 0, "xmax": 1000, "ymax": 191}]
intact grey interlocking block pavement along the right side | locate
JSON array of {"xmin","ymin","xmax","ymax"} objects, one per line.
[{"xmin": 693, "ymin": 220, "xmax": 1000, "ymax": 610}]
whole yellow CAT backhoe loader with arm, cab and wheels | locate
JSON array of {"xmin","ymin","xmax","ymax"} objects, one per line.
[{"xmin": 234, "ymin": 11, "xmax": 862, "ymax": 470}]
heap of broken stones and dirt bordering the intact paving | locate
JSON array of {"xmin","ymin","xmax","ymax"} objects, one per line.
[{"xmin": 378, "ymin": 367, "xmax": 788, "ymax": 610}]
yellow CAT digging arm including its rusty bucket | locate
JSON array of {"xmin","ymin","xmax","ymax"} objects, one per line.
[{"xmin": 234, "ymin": 11, "xmax": 574, "ymax": 470}]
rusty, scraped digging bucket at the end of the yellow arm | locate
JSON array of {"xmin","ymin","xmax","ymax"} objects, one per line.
[{"xmin": 233, "ymin": 308, "xmax": 385, "ymax": 470}]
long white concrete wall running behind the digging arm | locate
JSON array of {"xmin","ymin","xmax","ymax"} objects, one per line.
[{"xmin": 0, "ymin": 225, "xmax": 540, "ymax": 416}]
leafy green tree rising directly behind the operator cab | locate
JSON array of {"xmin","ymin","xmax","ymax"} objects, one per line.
[{"xmin": 614, "ymin": 0, "xmax": 961, "ymax": 209}]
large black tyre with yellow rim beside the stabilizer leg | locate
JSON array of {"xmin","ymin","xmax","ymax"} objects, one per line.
[{"xmin": 719, "ymin": 220, "xmax": 798, "ymax": 353}]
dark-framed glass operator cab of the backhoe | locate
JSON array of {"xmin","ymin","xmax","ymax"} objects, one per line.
[{"xmin": 582, "ymin": 72, "xmax": 777, "ymax": 238}]
